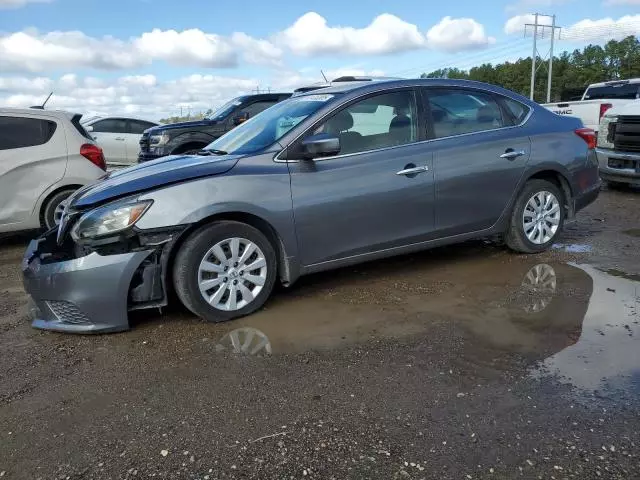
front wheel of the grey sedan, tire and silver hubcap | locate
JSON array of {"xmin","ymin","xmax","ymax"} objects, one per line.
[{"xmin": 173, "ymin": 221, "xmax": 278, "ymax": 322}]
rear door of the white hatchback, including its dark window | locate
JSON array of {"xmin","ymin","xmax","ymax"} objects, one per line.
[{"xmin": 0, "ymin": 114, "xmax": 67, "ymax": 227}]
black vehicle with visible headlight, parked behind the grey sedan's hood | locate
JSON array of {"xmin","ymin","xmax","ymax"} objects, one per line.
[{"xmin": 138, "ymin": 93, "xmax": 291, "ymax": 163}]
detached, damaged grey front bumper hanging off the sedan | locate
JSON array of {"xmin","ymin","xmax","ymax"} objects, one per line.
[{"xmin": 22, "ymin": 231, "xmax": 172, "ymax": 333}]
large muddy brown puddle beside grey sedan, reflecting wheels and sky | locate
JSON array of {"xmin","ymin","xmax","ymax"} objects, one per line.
[{"xmin": 217, "ymin": 258, "xmax": 640, "ymax": 400}]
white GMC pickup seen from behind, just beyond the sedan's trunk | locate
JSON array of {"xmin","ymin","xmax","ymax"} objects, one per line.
[{"xmin": 542, "ymin": 78, "xmax": 640, "ymax": 132}]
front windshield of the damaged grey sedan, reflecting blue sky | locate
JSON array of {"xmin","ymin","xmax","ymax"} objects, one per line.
[{"xmin": 205, "ymin": 94, "xmax": 334, "ymax": 154}]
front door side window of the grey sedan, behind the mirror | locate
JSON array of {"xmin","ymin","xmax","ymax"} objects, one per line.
[{"xmin": 313, "ymin": 90, "xmax": 418, "ymax": 155}]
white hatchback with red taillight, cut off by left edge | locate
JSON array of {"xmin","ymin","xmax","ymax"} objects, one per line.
[{"xmin": 0, "ymin": 108, "xmax": 106, "ymax": 232}]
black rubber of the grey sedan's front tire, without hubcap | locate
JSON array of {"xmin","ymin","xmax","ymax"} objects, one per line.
[{"xmin": 173, "ymin": 221, "xmax": 278, "ymax": 322}]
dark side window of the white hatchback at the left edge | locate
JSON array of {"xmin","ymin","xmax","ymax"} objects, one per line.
[{"xmin": 0, "ymin": 117, "xmax": 57, "ymax": 150}]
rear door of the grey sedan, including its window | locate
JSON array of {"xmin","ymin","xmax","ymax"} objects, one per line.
[{"xmin": 425, "ymin": 87, "xmax": 531, "ymax": 237}]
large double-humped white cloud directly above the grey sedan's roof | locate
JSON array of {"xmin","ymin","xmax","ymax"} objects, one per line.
[{"xmin": 275, "ymin": 12, "xmax": 424, "ymax": 55}]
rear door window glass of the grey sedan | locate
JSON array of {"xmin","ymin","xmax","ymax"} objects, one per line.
[{"xmin": 427, "ymin": 89, "xmax": 509, "ymax": 138}]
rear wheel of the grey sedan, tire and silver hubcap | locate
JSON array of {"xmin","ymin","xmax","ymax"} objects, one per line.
[{"xmin": 505, "ymin": 180, "xmax": 565, "ymax": 253}]
